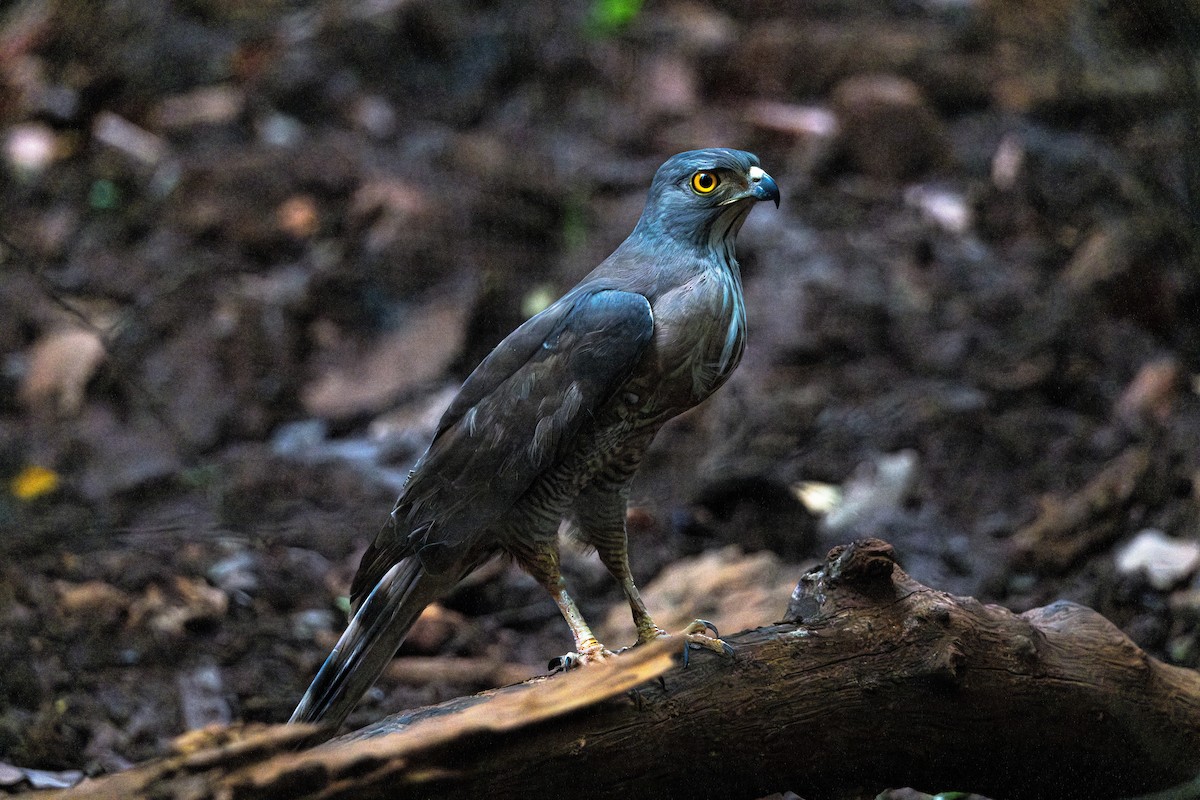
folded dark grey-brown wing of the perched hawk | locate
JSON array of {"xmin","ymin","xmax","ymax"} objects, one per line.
[{"xmin": 350, "ymin": 289, "xmax": 654, "ymax": 604}]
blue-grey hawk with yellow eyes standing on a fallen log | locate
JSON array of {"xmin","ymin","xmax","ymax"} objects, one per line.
[{"xmin": 292, "ymin": 149, "xmax": 779, "ymax": 724}]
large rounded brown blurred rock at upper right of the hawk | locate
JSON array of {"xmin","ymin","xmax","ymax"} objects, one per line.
[{"xmin": 832, "ymin": 74, "xmax": 949, "ymax": 181}]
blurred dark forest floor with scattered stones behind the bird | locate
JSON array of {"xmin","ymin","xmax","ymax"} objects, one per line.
[{"xmin": 0, "ymin": 0, "xmax": 1200, "ymax": 788}]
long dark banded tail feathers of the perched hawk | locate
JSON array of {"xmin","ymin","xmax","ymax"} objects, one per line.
[{"xmin": 289, "ymin": 558, "xmax": 461, "ymax": 726}]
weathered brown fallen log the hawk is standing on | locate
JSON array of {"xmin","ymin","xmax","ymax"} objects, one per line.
[{"xmin": 49, "ymin": 540, "xmax": 1200, "ymax": 800}]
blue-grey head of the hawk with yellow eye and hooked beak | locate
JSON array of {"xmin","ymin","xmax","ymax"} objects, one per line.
[{"xmin": 635, "ymin": 148, "xmax": 779, "ymax": 248}]
